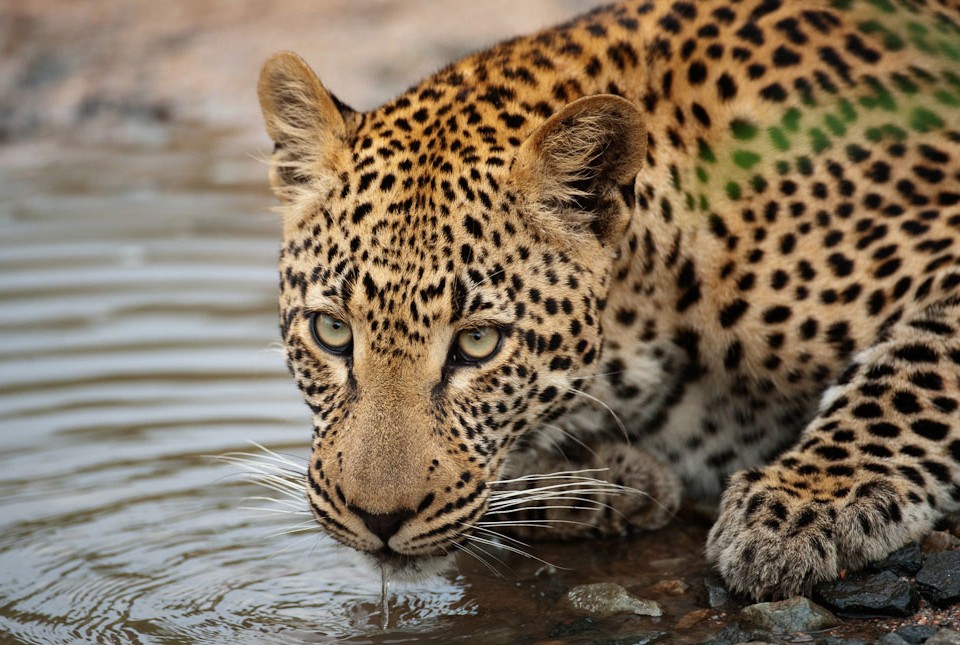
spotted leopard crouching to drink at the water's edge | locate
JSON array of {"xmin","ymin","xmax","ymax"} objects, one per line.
[{"xmin": 258, "ymin": 0, "xmax": 960, "ymax": 600}]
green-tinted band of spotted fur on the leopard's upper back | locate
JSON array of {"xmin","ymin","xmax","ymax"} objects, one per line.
[{"xmin": 678, "ymin": 0, "xmax": 960, "ymax": 213}]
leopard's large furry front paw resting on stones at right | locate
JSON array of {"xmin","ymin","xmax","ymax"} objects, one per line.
[{"xmin": 707, "ymin": 466, "xmax": 933, "ymax": 599}]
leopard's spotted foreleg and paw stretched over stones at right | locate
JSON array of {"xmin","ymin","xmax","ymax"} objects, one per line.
[{"xmin": 707, "ymin": 300, "xmax": 960, "ymax": 598}]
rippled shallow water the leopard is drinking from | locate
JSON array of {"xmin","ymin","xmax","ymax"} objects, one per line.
[{"xmin": 0, "ymin": 137, "xmax": 722, "ymax": 643}]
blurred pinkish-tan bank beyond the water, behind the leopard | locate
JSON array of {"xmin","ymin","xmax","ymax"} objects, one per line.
[{"xmin": 0, "ymin": 0, "xmax": 599, "ymax": 145}]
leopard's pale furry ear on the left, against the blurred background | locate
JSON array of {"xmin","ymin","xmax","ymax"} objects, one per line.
[{"xmin": 257, "ymin": 52, "xmax": 358, "ymax": 200}]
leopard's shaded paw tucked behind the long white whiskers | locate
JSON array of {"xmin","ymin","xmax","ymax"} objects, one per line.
[{"xmin": 484, "ymin": 441, "xmax": 681, "ymax": 540}]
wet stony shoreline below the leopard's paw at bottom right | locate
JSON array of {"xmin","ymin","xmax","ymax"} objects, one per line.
[{"xmin": 541, "ymin": 531, "xmax": 960, "ymax": 645}]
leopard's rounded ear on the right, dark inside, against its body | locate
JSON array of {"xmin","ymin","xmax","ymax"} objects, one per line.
[{"xmin": 514, "ymin": 94, "xmax": 647, "ymax": 244}]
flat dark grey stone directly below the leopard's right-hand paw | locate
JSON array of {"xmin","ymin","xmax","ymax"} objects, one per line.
[{"xmin": 813, "ymin": 571, "xmax": 920, "ymax": 618}]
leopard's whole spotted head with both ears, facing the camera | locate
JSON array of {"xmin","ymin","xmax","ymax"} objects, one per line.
[{"xmin": 260, "ymin": 54, "xmax": 645, "ymax": 570}]
